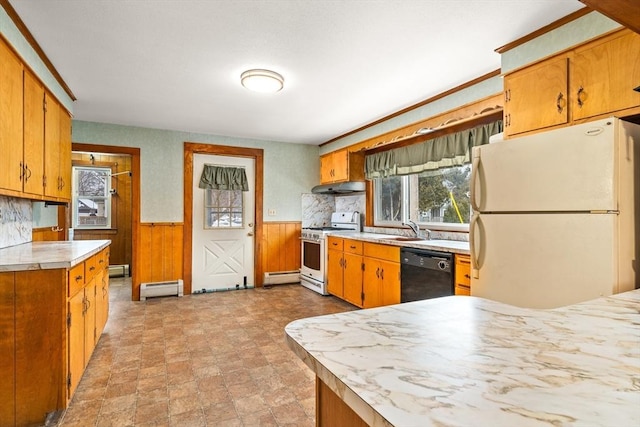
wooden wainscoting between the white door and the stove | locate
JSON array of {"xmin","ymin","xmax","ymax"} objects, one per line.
[{"xmin": 261, "ymin": 222, "xmax": 302, "ymax": 272}]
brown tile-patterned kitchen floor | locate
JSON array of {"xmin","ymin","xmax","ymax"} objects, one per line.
[{"xmin": 58, "ymin": 278, "xmax": 355, "ymax": 427}]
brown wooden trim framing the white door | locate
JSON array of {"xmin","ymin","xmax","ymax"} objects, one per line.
[{"xmin": 182, "ymin": 141, "xmax": 264, "ymax": 295}]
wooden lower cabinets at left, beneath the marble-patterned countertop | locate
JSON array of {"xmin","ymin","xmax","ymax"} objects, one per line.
[{"xmin": 0, "ymin": 248, "xmax": 108, "ymax": 427}]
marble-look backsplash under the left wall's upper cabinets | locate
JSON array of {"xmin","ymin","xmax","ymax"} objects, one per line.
[{"xmin": 0, "ymin": 196, "xmax": 33, "ymax": 249}]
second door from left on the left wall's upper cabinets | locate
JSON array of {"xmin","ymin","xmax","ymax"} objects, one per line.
[{"xmin": 23, "ymin": 70, "xmax": 44, "ymax": 196}]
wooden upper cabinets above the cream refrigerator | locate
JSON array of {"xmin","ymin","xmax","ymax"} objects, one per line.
[{"xmin": 504, "ymin": 29, "xmax": 640, "ymax": 137}]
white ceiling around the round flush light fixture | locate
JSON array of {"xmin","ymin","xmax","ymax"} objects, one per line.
[{"xmin": 10, "ymin": 0, "xmax": 583, "ymax": 144}]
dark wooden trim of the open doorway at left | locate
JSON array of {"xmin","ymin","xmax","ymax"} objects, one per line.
[{"xmin": 71, "ymin": 142, "xmax": 140, "ymax": 301}]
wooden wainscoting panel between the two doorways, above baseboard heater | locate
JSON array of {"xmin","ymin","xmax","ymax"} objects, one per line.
[{"xmin": 133, "ymin": 222, "xmax": 184, "ymax": 301}]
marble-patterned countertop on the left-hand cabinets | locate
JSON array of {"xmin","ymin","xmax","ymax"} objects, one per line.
[{"xmin": 0, "ymin": 240, "xmax": 111, "ymax": 272}]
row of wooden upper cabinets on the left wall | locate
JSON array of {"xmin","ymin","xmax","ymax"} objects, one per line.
[{"xmin": 0, "ymin": 39, "xmax": 71, "ymax": 202}]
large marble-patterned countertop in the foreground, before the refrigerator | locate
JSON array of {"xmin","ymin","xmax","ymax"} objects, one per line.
[{"xmin": 285, "ymin": 290, "xmax": 640, "ymax": 427}]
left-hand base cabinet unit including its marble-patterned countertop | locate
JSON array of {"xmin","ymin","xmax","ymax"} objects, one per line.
[{"xmin": 0, "ymin": 240, "xmax": 111, "ymax": 426}]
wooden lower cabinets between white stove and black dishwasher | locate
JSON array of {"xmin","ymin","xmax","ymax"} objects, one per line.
[{"xmin": 327, "ymin": 236, "xmax": 400, "ymax": 308}]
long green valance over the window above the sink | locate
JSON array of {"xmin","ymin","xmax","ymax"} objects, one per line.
[{"xmin": 365, "ymin": 120, "xmax": 502, "ymax": 179}]
